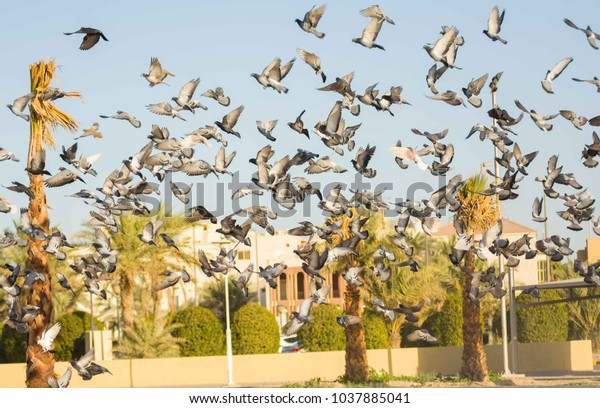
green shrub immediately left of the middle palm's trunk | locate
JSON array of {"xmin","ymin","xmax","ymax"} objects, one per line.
[{"xmin": 298, "ymin": 304, "xmax": 346, "ymax": 351}]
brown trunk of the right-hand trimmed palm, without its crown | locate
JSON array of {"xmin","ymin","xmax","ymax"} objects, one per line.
[{"xmin": 461, "ymin": 251, "xmax": 489, "ymax": 381}]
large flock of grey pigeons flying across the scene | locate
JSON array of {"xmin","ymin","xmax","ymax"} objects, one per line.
[{"xmin": 0, "ymin": 5, "xmax": 600, "ymax": 386}]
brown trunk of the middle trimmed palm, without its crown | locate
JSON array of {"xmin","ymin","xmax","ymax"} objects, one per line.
[{"xmin": 344, "ymin": 285, "xmax": 369, "ymax": 382}]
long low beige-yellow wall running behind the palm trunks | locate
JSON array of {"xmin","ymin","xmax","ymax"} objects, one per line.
[{"xmin": 0, "ymin": 340, "xmax": 593, "ymax": 388}]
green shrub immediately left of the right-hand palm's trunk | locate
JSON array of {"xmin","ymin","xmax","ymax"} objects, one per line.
[{"xmin": 423, "ymin": 290, "xmax": 463, "ymax": 346}]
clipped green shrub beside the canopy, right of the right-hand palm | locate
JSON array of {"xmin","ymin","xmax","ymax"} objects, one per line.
[{"xmin": 517, "ymin": 290, "xmax": 569, "ymax": 343}]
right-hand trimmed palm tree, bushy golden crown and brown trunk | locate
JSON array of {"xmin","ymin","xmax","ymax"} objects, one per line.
[{"xmin": 454, "ymin": 175, "xmax": 500, "ymax": 381}]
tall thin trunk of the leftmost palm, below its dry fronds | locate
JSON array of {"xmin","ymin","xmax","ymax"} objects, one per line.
[{"xmin": 26, "ymin": 128, "xmax": 54, "ymax": 388}]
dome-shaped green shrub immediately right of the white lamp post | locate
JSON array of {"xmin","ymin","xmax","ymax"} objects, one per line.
[{"xmin": 231, "ymin": 303, "xmax": 280, "ymax": 354}]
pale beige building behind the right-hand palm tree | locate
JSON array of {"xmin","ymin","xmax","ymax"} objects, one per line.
[{"xmin": 432, "ymin": 218, "xmax": 544, "ymax": 285}]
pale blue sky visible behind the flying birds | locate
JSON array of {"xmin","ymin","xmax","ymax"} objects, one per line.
[{"xmin": 0, "ymin": 0, "xmax": 600, "ymax": 252}]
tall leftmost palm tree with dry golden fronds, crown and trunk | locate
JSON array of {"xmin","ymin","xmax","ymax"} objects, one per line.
[{"xmin": 26, "ymin": 60, "xmax": 80, "ymax": 388}]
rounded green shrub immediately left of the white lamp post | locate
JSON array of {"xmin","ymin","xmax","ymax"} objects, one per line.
[{"xmin": 173, "ymin": 306, "xmax": 225, "ymax": 357}]
